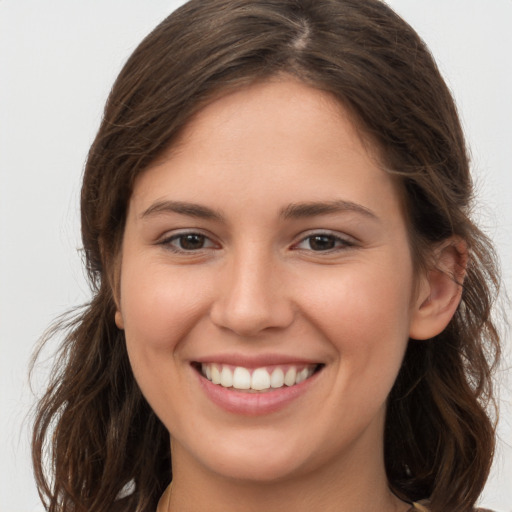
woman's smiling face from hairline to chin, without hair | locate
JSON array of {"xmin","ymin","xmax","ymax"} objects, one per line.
[{"xmin": 116, "ymin": 79, "xmax": 426, "ymax": 481}]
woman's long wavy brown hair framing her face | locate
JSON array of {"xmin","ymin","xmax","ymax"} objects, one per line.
[{"xmin": 33, "ymin": 0, "xmax": 499, "ymax": 512}]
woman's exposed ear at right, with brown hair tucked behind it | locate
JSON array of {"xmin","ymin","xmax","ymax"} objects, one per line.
[{"xmin": 409, "ymin": 237, "xmax": 468, "ymax": 340}]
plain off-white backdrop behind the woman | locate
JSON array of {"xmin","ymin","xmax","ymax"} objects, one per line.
[{"xmin": 0, "ymin": 0, "xmax": 512, "ymax": 512}]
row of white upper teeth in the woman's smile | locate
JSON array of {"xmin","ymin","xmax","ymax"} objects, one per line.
[{"xmin": 201, "ymin": 363, "xmax": 314, "ymax": 391}]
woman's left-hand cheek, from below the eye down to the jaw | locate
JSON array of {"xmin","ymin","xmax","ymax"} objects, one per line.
[{"xmin": 121, "ymin": 259, "xmax": 209, "ymax": 430}]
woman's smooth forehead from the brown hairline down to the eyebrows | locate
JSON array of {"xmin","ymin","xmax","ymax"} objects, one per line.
[{"xmin": 134, "ymin": 77, "xmax": 404, "ymax": 225}]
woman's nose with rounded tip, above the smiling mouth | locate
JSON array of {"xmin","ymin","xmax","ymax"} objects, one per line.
[{"xmin": 210, "ymin": 251, "xmax": 294, "ymax": 337}]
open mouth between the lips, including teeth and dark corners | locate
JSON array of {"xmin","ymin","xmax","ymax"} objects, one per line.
[{"xmin": 192, "ymin": 362, "xmax": 324, "ymax": 393}]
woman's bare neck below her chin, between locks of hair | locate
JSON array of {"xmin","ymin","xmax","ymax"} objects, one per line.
[{"xmin": 165, "ymin": 438, "xmax": 409, "ymax": 512}]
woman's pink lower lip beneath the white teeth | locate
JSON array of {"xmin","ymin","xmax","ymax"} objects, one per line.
[{"xmin": 197, "ymin": 372, "xmax": 320, "ymax": 416}]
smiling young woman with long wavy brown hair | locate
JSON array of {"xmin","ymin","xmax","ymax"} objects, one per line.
[{"xmin": 34, "ymin": 0, "xmax": 499, "ymax": 512}]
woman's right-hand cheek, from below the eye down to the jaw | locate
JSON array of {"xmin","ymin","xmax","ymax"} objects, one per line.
[{"xmin": 300, "ymin": 262, "xmax": 412, "ymax": 431}]
